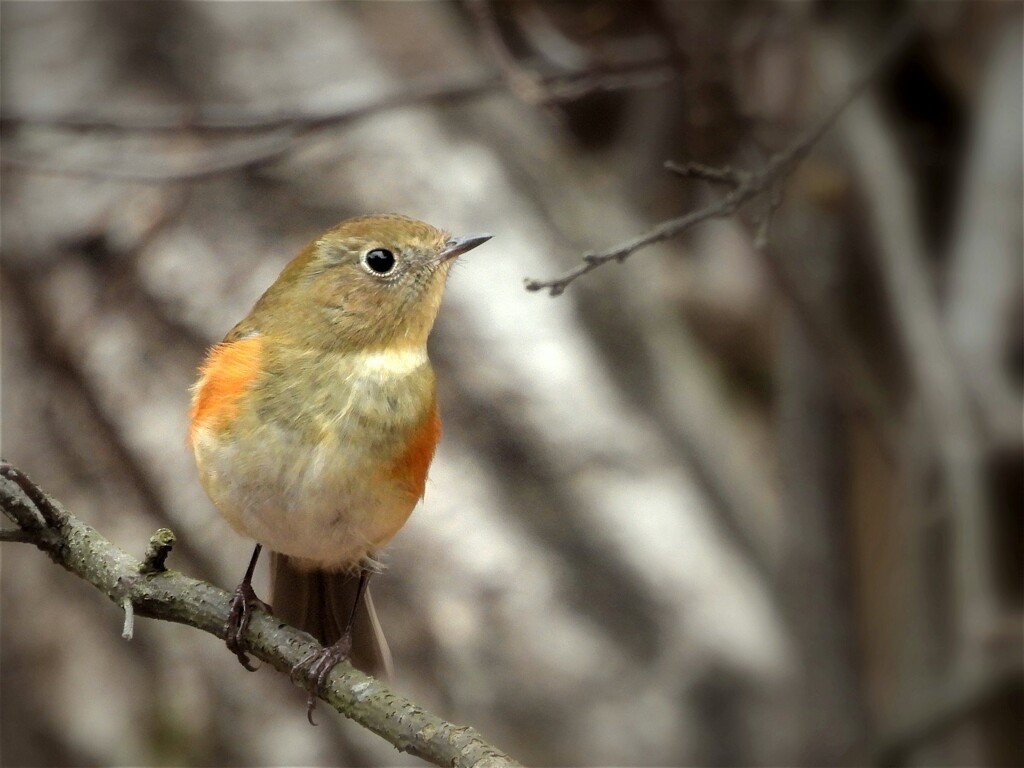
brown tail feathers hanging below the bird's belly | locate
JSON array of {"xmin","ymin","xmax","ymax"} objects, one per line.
[{"xmin": 270, "ymin": 552, "xmax": 394, "ymax": 680}]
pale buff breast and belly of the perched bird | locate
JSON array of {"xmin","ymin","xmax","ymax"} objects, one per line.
[{"xmin": 194, "ymin": 350, "xmax": 436, "ymax": 568}]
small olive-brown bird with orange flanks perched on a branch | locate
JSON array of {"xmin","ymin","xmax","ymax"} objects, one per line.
[{"xmin": 188, "ymin": 214, "xmax": 490, "ymax": 723}]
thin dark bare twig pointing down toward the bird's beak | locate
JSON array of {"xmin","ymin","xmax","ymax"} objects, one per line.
[{"xmin": 524, "ymin": 17, "xmax": 916, "ymax": 296}]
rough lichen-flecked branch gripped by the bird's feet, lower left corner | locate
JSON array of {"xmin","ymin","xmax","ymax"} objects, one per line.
[{"xmin": 0, "ymin": 460, "xmax": 518, "ymax": 768}]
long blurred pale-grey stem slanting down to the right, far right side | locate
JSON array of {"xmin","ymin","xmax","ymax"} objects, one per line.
[{"xmin": 815, "ymin": 28, "xmax": 999, "ymax": 673}]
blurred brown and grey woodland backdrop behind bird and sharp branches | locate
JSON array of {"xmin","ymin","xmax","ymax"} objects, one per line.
[{"xmin": 0, "ymin": 0, "xmax": 1024, "ymax": 766}]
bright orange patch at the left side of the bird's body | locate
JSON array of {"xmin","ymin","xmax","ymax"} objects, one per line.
[{"xmin": 188, "ymin": 336, "xmax": 263, "ymax": 444}]
